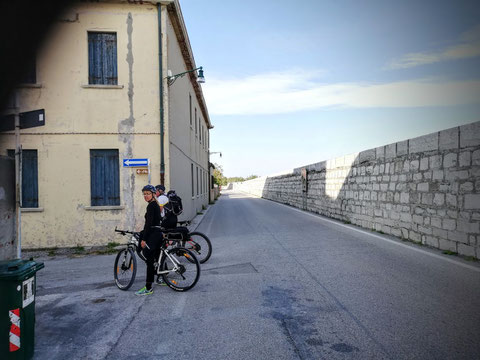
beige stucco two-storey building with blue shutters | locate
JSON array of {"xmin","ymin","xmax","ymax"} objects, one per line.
[{"xmin": 0, "ymin": 0, "xmax": 212, "ymax": 248}]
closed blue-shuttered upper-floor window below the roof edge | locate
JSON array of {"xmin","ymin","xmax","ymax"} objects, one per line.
[{"xmin": 88, "ymin": 32, "xmax": 117, "ymax": 85}]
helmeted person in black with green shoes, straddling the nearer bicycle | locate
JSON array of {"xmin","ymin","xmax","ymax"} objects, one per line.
[{"xmin": 135, "ymin": 185, "xmax": 162, "ymax": 295}]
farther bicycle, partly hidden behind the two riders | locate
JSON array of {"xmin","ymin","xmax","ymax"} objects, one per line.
[{"xmin": 171, "ymin": 220, "xmax": 212, "ymax": 264}]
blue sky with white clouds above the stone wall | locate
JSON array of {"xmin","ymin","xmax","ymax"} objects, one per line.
[{"xmin": 180, "ymin": 0, "xmax": 480, "ymax": 177}]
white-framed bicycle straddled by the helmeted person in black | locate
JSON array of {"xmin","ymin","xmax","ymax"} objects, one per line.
[{"xmin": 113, "ymin": 228, "xmax": 200, "ymax": 291}]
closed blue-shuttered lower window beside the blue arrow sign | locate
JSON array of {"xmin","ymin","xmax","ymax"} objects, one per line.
[{"xmin": 90, "ymin": 149, "xmax": 120, "ymax": 206}]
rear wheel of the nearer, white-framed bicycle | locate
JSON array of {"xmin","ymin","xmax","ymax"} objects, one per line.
[{"xmin": 160, "ymin": 247, "xmax": 200, "ymax": 291}]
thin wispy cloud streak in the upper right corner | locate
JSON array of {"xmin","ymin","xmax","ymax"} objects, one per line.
[{"xmin": 386, "ymin": 25, "xmax": 480, "ymax": 69}]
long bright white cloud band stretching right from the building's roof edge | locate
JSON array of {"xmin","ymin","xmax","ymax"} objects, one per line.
[{"xmin": 203, "ymin": 69, "xmax": 480, "ymax": 115}]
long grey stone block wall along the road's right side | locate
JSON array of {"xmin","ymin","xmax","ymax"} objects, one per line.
[{"xmin": 234, "ymin": 122, "xmax": 480, "ymax": 258}]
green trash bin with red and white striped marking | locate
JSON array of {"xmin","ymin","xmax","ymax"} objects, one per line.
[{"xmin": 0, "ymin": 259, "xmax": 44, "ymax": 359}]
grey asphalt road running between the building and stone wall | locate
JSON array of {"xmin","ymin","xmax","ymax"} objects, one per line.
[{"xmin": 35, "ymin": 192, "xmax": 480, "ymax": 360}]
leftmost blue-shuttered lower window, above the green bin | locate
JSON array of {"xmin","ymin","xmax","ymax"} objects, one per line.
[{"xmin": 8, "ymin": 150, "xmax": 38, "ymax": 208}]
